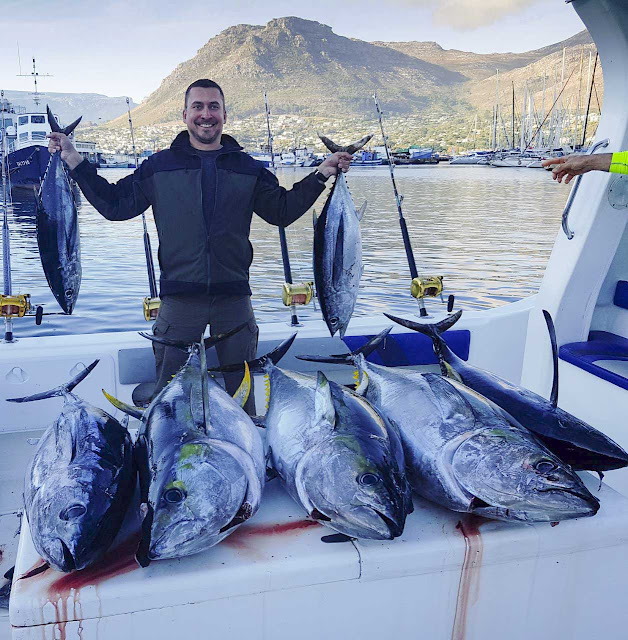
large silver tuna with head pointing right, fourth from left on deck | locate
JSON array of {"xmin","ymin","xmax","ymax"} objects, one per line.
[{"xmin": 298, "ymin": 329, "xmax": 599, "ymax": 522}]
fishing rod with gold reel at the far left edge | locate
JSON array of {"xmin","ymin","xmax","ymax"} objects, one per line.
[{"xmin": 0, "ymin": 91, "xmax": 43, "ymax": 342}]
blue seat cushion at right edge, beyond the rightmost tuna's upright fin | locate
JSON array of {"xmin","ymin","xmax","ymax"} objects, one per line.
[{"xmin": 558, "ymin": 331, "xmax": 628, "ymax": 390}]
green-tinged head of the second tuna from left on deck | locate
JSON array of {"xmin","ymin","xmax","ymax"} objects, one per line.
[{"xmin": 146, "ymin": 440, "xmax": 251, "ymax": 562}]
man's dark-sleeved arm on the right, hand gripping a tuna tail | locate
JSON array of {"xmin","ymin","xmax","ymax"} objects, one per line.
[{"xmin": 253, "ymin": 152, "xmax": 352, "ymax": 227}]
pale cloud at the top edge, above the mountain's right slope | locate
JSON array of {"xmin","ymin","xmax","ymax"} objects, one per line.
[{"xmin": 401, "ymin": 0, "xmax": 542, "ymax": 31}]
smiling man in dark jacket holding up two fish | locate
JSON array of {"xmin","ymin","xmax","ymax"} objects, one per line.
[{"xmin": 48, "ymin": 79, "xmax": 352, "ymax": 414}]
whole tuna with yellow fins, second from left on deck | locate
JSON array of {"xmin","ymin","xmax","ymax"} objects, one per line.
[{"xmin": 106, "ymin": 325, "xmax": 266, "ymax": 566}]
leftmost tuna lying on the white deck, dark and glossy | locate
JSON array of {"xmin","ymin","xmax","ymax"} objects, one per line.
[{"xmin": 9, "ymin": 360, "xmax": 137, "ymax": 572}]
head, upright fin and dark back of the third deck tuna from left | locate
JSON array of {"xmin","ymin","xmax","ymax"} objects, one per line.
[{"xmin": 295, "ymin": 373, "xmax": 412, "ymax": 540}]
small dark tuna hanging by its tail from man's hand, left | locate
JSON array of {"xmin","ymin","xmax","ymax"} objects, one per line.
[{"xmin": 37, "ymin": 107, "xmax": 81, "ymax": 314}]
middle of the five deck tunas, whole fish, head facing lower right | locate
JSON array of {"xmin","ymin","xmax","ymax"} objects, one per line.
[{"xmin": 216, "ymin": 334, "xmax": 413, "ymax": 540}]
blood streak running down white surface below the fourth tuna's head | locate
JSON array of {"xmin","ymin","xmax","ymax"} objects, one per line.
[{"xmin": 451, "ymin": 514, "xmax": 487, "ymax": 640}]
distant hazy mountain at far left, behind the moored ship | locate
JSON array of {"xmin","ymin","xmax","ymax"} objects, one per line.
[{"xmin": 4, "ymin": 90, "xmax": 137, "ymax": 125}]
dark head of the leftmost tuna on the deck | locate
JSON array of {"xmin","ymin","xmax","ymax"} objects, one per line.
[{"xmin": 29, "ymin": 478, "xmax": 115, "ymax": 572}]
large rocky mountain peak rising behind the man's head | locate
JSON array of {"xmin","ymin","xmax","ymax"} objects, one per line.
[{"xmin": 109, "ymin": 17, "xmax": 467, "ymax": 125}]
